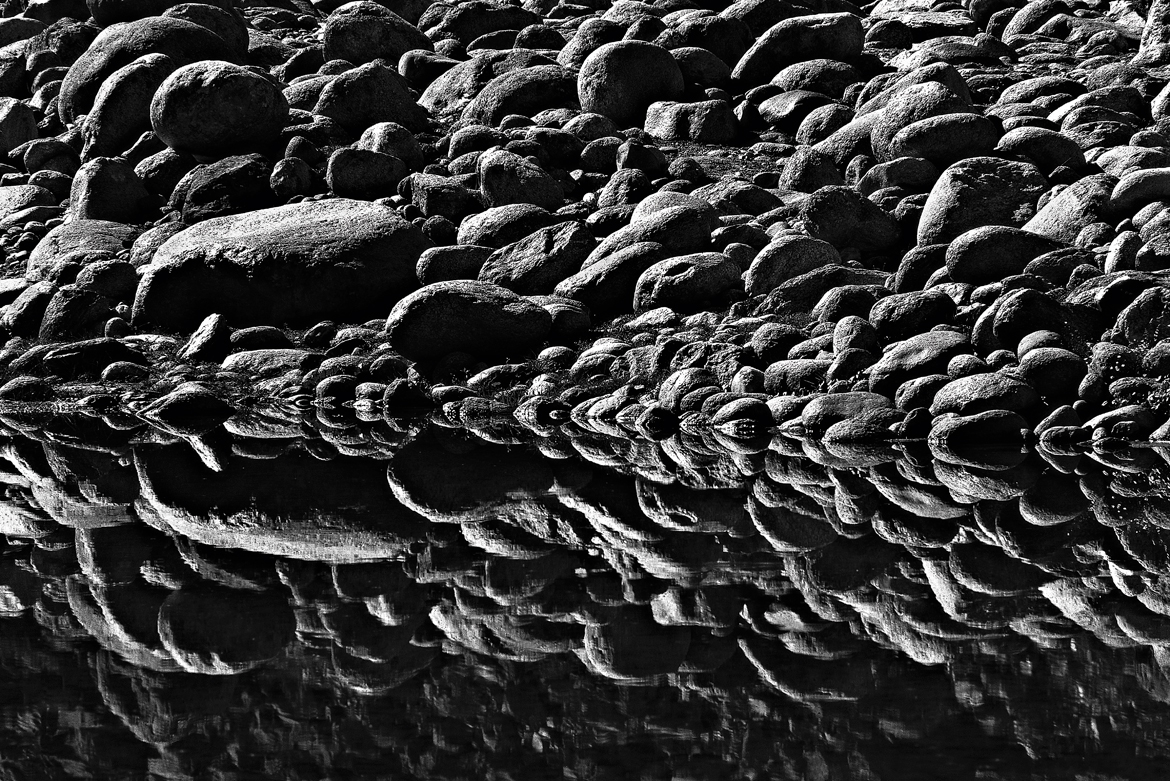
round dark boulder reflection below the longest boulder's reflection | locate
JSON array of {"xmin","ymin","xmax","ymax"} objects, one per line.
[{"xmin": 158, "ymin": 586, "xmax": 296, "ymax": 675}]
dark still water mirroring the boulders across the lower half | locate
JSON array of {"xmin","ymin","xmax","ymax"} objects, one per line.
[{"xmin": 0, "ymin": 410, "xmax": 1170, "ymax": 781}]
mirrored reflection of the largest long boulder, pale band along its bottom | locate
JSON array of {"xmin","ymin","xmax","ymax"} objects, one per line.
[{"xmin": 135, "ymin": 445, "xmax": 427, "ymax": 562}]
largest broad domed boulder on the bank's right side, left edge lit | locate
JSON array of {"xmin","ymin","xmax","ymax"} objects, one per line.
[{"xmin": 918, "ymin": 157, "xmax": 1048, "ymax": 244}]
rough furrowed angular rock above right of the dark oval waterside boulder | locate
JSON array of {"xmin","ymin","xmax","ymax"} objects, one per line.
[{"xmin": 479, "ymin": 222, "xmax": 597, "ymax": 296}]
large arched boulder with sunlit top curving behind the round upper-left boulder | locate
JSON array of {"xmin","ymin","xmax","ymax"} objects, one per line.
[{"xmin": 57, "ymin": 16, "xmax": 238, "ymax": 124}]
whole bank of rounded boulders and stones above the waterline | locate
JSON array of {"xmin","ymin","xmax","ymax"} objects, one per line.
[{"xmin": 0, "ymin": 0, "xmax": 1170, "ymax": 454}]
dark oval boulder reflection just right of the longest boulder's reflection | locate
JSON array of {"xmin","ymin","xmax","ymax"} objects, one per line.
[{"xmin": 386, "ymin": 434, "xmax": 553, "ymax": 523}]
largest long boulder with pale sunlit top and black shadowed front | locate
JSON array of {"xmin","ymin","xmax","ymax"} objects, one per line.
[{"xmin": 133, "ymin": 199, "xmax": 428, "ymax": 330}]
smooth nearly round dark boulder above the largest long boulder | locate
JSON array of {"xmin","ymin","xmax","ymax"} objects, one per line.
[{"xmin": 150, "ymin": 60, "xmax": 289, "ymax": 158}]
